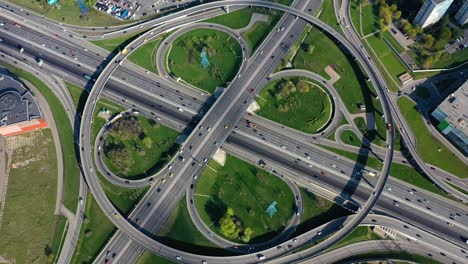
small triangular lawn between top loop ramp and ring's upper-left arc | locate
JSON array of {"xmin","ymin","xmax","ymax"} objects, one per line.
[{"xmin": 128, "ymin": 38, "xmax": 162, "ymax": 73}]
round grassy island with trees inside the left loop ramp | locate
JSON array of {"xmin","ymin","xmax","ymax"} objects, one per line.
[{"xmin": 98, "ymin": 115, "xmax": 179, "ymax": 180}]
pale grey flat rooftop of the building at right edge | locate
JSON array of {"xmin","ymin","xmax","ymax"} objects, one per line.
[{"xmin": 438, "ymin": 80, "xmax": 468, "ymax": 136}]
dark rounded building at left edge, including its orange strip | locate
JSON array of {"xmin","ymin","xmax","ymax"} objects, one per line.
[{"xmin": 0, "ymin": 68, "xmax": 47, "ymax": 136}]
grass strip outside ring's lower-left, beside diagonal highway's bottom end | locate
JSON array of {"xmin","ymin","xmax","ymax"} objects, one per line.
[{"xmin": 71, "ymin": 192, "xmax": 115, "ymax": 264}]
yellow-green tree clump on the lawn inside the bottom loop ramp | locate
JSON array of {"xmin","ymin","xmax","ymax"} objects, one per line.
[{"xmin": 219, "ymin": 207, "xmax": 253, "ymax": 243}]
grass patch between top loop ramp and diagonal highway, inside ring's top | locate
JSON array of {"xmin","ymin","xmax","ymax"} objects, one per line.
[{"xmin": 242, "ymin": 8, "xmax": 283, "ymax": 51}]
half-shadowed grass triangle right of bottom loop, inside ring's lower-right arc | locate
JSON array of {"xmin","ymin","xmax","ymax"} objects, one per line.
[{"xmin": 295, "ymin": 188, "xmax": 349, "ymax": 235}]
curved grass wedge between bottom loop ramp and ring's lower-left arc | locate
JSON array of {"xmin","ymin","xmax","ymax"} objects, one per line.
[{"xmin": 156, "ymin": 196, "xmax": 230, "ymax": 256}]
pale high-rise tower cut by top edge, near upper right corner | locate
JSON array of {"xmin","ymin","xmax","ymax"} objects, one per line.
[{"xmin": 413, "ymin": 0, "xmax": 454, "ymax": 28}]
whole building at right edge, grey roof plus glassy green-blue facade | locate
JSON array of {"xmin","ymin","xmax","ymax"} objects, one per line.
[{"xmin": 431, "ymin": 81, "xmax": 468, "ymax": 156}]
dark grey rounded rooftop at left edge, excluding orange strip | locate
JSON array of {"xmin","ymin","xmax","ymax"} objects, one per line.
[{"xmin": 0, "ymin": 68, "xmax": 41, "ymax": 127}]
